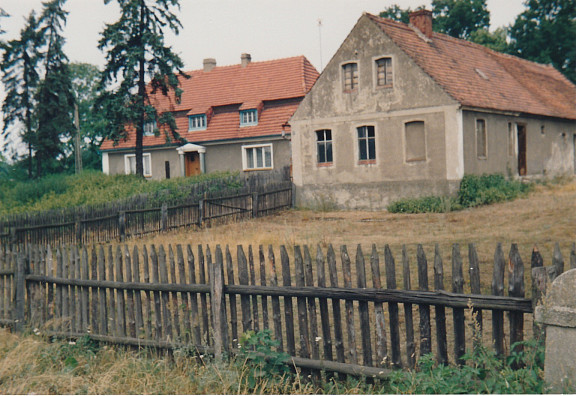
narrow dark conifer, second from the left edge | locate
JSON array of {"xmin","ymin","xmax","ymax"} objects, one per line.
[{"xmin": 35, "ymin": 0, "xmax": 75, "ymax": 177}]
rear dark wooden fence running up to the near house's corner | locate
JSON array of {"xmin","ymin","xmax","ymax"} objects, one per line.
[{"xmin": 0, "ymin": 186, "xmax": 292, "ymax": 245}]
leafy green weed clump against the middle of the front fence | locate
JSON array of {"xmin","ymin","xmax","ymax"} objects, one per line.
[{"xmin": 237, "ymin": 329, "xmax": 290, "ymax": 389}]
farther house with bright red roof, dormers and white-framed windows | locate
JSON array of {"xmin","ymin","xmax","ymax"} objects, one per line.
[{"xmin": 100, "ymin": 54, "xmax": 318, "ymax": 179}]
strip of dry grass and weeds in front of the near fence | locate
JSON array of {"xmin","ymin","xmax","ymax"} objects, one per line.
[{"xmin": 0, "ymin": 329, "xmax": 546, "ymax": 394}]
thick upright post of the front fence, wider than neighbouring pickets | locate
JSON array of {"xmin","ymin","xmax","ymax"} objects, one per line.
[{"xmin": 209, "ymin": 245, "xmax": 227, "ymax": 359}]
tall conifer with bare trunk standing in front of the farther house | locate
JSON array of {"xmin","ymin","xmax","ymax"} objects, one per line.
[{"xmin": 98, "ymin": 0, "xmax": 188, "ymax": 176}]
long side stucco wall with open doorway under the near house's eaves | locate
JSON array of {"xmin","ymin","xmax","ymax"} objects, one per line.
[{"xmin": 463, "ymin": 111, "xmax": 576, "ymax": 177}]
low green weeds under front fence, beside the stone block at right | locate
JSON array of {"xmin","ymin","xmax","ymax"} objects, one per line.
[{"xmin": 386, "ymin": 341, "xmax": 544, "ymax": 394}]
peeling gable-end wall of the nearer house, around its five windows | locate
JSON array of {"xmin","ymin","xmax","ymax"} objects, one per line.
[{"xmin": 290, "ymin": 13, "xmax": 464, "ymax": 209}]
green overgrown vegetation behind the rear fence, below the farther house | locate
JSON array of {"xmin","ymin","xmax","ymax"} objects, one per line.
[{"xmin": 0, "ymin": 171, "xmax": 241, "ymax": 216}]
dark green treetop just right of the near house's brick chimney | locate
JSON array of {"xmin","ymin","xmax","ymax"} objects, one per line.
[{"xmin": 432, "ymin": 0, "xmax": 490, "ymax": 39}]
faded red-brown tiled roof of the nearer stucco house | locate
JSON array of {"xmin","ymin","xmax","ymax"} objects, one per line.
[{"xmin": 365, "ymin": 14, "xmax": 576, "ymax": 119}]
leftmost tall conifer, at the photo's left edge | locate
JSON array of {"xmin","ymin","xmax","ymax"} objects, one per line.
[{"xmin": 0, "ymin": 11, "xmax": 42, "ymax": 177}]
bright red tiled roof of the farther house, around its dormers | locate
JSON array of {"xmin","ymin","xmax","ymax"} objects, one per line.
[{"xmin": 100, "ymin": 56, "xmax": 318, "ymax": 150}]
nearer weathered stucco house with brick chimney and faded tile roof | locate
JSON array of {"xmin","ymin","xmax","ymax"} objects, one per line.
[{"xmin": 290, "ymin": 10, "xmax": 576, "ymax": 209}]
